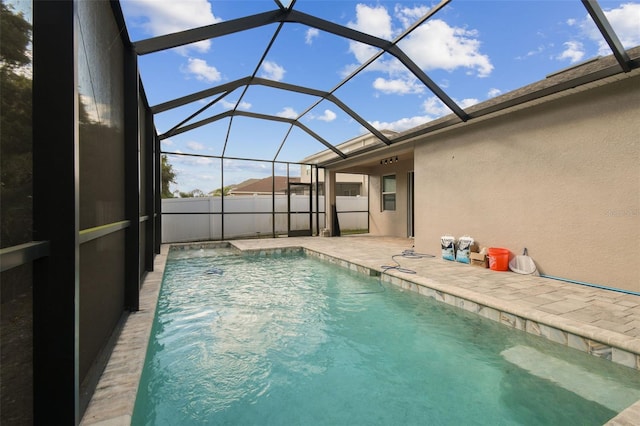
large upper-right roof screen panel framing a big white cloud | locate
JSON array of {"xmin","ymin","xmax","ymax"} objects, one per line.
[{"xmin": 408, "ymin": 1, "xmax": 596, "ymax": 98}]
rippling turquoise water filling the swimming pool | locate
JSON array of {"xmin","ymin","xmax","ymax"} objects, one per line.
[{"xmin": 132, "ymin": 249, "xmax": 640, "ymax": 425}]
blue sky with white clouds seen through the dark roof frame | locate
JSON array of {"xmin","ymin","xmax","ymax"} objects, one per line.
[{"xmin": 121, "ymin": 0, "xmax": 640, "ymax": 192}]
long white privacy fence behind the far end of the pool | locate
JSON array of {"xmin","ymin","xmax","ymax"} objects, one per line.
[{"xmin": 162, "ymin": 195, "xmax": 369, "ymax": 243}]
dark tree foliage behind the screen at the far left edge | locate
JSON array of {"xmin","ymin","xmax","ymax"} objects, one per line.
[{"xmin": 0, "ymin": 4, "xmax": 33, "ymax": 424}]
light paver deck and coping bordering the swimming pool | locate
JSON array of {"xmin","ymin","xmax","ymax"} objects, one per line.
[{"xmin": 81, "ymin": 235, "xmax": 640, "ymax": 426}]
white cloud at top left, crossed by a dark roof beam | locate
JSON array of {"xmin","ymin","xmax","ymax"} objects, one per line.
[{"xmin": 121, "ymin": 0, "xmax": 221, "ymax": 53}]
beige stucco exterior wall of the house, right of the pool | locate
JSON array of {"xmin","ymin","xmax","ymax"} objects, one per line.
[{"xmin": 404, "ymin": 75, "xmax": 640, "ymax": 292}]
